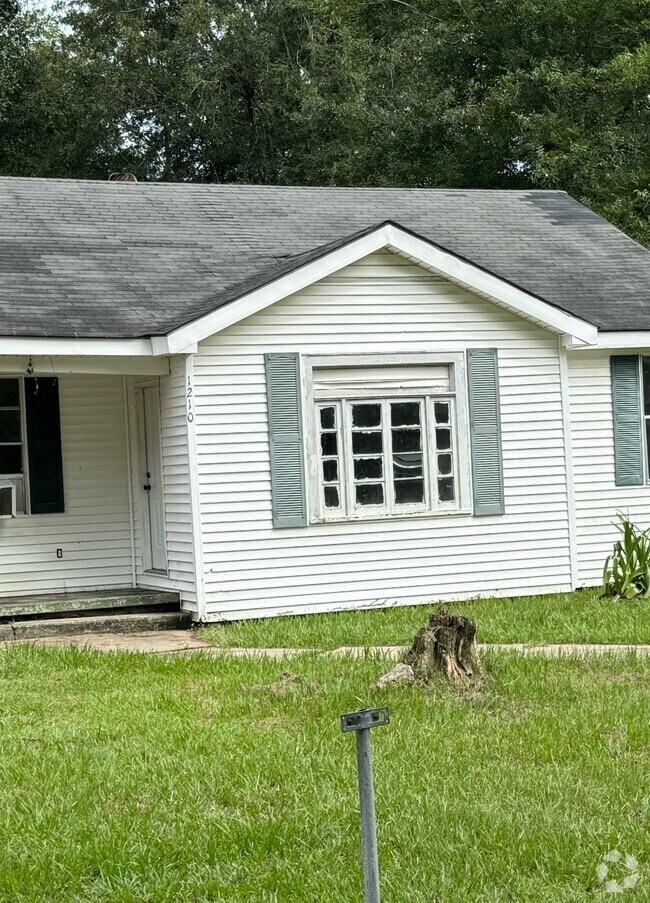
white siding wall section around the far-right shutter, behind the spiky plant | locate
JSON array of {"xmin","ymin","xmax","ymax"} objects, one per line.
[{"xmin": 569, "ymin": 351, "xmax": 650, "ymax": 586}]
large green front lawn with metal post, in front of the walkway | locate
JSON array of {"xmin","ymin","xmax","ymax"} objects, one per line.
[{"xmin": 0, "ymin": 648, "xmax": 650, "ymax": 903}]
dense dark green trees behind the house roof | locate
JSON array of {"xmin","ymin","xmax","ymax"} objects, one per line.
[{"xmin": 0, "ymin": 0, "xmax": 650, "ymax": 243}]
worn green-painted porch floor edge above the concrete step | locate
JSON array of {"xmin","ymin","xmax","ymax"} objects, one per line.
[{"xmin": 0, "ymin": 588, "xmax": 180, "ymax": 623}]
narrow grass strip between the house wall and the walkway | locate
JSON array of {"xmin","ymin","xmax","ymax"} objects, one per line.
[{"xmin": 202, "ymin": 590, "xmax": 650, "ymax": 649}]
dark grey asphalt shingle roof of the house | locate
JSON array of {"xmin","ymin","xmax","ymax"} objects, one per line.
[{"xmin": 0, "ymin": 177, "xmax": 650, "ymax": 338}]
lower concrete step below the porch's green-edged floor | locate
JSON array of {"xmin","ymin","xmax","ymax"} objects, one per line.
[{"xmin": 0, "ymin": 611, "xmax": 191, "ymax": 641}]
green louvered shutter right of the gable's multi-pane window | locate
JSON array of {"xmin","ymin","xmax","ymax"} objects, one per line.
[{"xmin": 467, "ymin": 348, "xmax": 504, "ymax": 515}]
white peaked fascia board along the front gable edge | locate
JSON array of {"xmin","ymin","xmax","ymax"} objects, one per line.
[{"xmin": 167, "ymin": 224, "xmax": 598, "ymax": 354}]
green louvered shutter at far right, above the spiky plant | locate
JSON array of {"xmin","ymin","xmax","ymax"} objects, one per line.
[{"xmin": 610, "ymin": 354, "xmax": 643, "ymax": 486}]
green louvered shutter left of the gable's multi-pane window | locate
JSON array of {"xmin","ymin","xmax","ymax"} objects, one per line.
[{"xmin": 264, "ymin": 354, "xmax": 307, "ymax": 527}]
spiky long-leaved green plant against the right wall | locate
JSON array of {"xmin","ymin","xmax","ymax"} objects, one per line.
[{"xmin": 603, "ymin": 514, "xmax": 650, "ymax": 600}]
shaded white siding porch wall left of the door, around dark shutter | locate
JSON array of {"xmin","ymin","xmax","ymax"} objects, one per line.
[{"xmin": 0, "ymin": 375, "xmax": 132, "ymax": 596}]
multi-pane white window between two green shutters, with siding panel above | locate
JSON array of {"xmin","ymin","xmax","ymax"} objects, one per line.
[{"xmin": 312, "ymin": 356, "xmax": 466, "ymax": 519}]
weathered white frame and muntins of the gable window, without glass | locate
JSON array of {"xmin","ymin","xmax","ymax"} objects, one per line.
[{"xmin": 302, "ymin": 351, "xmax": 472, "ymax": 523}]
